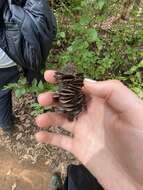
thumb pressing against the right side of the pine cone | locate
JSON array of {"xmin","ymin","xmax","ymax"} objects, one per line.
[{"xmin": 84, "ymin": 79, "xmax": 143, "ymax": 112}]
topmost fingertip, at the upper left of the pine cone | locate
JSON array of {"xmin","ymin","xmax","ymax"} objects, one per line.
[{"xmin": 44, "ymin": 70, "xmax": 57, "ymax": 84}]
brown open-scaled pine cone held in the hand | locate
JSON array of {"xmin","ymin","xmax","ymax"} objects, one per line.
[{"xmin": 54, "ymin": 64, "xmax": 86, "ymax": 121}]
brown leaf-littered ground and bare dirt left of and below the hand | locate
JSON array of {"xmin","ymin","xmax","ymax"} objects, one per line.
[{"xmin": 0, "ymin": 95, "xmax": 78, "ymax": 190}]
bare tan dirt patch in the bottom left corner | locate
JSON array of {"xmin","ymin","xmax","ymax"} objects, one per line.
[{"xmin": 0, "ymin": 148, "xmax": 51, "ymax": 190}]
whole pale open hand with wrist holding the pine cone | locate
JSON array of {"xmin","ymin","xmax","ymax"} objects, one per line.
[{"xmin": 36, "ymin": 71, "xmax": 143, "ymax": 190}]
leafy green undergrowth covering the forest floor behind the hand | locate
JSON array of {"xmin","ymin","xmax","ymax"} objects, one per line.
[{"xmin": 8, "ymin": 0, "xmax": 143, "ymax": 114}]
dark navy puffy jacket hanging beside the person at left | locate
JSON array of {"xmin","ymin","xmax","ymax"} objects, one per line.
[{"xmin": 0, "ymin": 0, "xmax": 56, "ymax": 71}]
